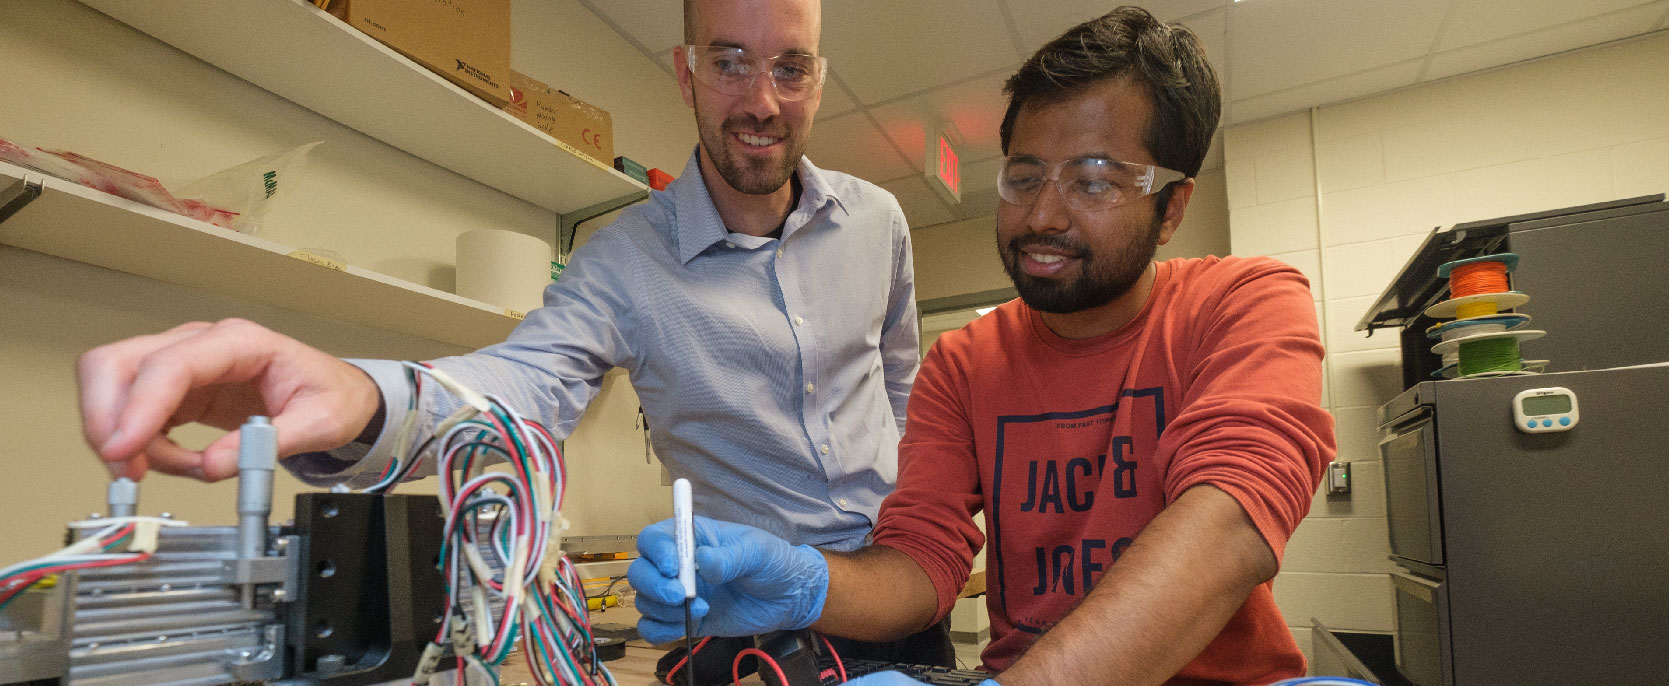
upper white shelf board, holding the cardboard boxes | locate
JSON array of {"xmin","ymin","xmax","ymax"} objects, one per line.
[{"xmin": 82, "ymin": 0, "xmax": 648, "ymax": 214}]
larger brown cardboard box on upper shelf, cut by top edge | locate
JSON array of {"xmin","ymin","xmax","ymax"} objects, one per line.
[{"xmin": 330, "ymin": 0, "xmax": 511, "ymax": 107}]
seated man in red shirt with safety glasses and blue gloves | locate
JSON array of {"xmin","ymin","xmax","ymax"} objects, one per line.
[{"xmin": 631, "ymin": 8, "xmax": 1334, "ymax": 686}]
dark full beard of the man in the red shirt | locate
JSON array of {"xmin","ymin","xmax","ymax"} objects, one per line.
[{"xmin": 998, "ymin": 217, "xmax": 1163, "ymax": 314}]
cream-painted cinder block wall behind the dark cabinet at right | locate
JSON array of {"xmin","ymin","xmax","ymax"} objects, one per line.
[{"xmin": 1225, "ymin": 32, "xmax": 1669, "ymax": 660}]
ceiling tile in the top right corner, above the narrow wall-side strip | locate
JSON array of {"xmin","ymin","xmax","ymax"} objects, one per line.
[{"xmin": 1437, "ymin": 0, "xmax": 1657, "ymax": 52}]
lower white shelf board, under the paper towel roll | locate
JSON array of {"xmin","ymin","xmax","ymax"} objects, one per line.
[{"xmin": 0, "ymin": 162, "xmax": 519, "ymax": 347}]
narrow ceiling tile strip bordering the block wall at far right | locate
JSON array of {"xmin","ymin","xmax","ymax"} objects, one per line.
[{"xmin": 1425, "ymin": 2, "xmax": 1669, "ymax": 80}]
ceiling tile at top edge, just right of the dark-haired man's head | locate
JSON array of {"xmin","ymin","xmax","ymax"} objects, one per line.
[{"xmin": 1228, "ymin": 0, "xmax": 1449, "ymax": 99}]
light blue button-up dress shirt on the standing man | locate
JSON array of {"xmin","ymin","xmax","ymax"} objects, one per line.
[{"xmin": 285, "ymin": 155, "xmax": 920, "ymax": 549}]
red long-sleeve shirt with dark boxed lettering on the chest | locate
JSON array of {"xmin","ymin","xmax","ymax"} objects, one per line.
[{"xmin": 875, "ymin": 257, "xmax": 1334, "ymax": 684}]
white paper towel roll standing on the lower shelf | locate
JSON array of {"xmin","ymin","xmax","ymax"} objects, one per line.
[{"xmin": 457, "ymin": 229, "xmax": 551, "ymax": 312}]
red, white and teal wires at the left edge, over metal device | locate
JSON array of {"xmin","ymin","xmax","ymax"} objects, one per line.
[{"xmin": 0, "ymin": 517, "xmax": 185, "ymax": 609}]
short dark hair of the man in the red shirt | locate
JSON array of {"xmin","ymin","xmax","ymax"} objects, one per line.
[{"xmin": 1001, "ymin": 7, "xmax": 1222, "ymax": 180}]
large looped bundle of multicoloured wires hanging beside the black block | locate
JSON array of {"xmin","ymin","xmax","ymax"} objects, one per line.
[{"xmin": 392, "ymin": 364, "xmax": 614, "ymax": 686}]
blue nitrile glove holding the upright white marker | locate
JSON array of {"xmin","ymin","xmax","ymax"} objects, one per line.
[{"xmin": 626, "ymin": 516, "xmax": 829, "ymax": 644}]
